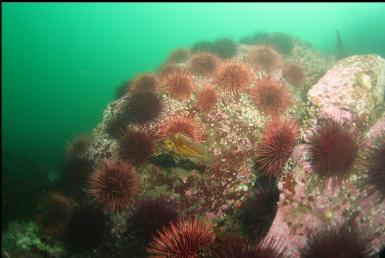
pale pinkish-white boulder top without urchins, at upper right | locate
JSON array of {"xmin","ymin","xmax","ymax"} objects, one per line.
[{"xmin": 307, "ymin": 55, "xmax": 385, "ymax": 126}]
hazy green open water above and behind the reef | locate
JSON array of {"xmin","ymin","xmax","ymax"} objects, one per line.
[{"xmin": 2, "ymin": 3, "xmax": 385, "ymax": 170}]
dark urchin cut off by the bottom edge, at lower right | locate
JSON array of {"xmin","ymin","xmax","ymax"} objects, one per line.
[{"xmin": 299, "ymin": 222, "xmax": 372, "ymax": 258}]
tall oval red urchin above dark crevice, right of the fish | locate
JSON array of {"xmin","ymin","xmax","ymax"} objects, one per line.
[{"xmin": 256, "ymin": 119, "xmax": 299, "ymax": 177}]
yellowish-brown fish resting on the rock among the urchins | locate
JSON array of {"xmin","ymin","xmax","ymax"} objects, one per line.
[{"xmin": 163, "ymin": 134, "xmax": 211, "ymax": 163}]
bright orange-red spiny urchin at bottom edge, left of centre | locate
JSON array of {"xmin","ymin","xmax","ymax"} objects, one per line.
[{"xmin": 147, "ymin": 218, "xmax": 215, "ymax": 258}]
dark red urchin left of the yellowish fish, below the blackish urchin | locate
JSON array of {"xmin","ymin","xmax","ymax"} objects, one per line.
[{"xmin": 119, "ymin": 131, "xmax": 155, "ymax": 165}]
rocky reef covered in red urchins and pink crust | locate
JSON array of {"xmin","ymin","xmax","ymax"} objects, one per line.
[{"xmin": 3, "ymin": 34, "xmax": 385, "ymax": 258}]
